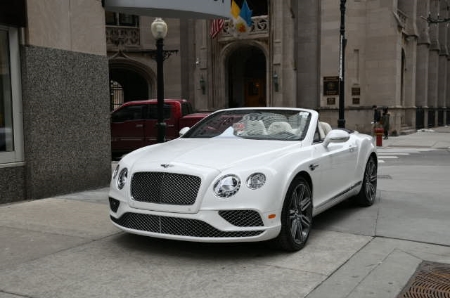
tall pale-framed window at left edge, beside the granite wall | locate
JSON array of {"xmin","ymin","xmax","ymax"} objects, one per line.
[{"xmin": 0, "ymin": 26, "xmax": 23, "ymax": 164}]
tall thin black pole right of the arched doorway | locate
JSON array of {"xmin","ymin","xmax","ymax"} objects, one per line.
[{"xmin": 338, "ymin": 0, "xmax": 347, "ymax": 128}]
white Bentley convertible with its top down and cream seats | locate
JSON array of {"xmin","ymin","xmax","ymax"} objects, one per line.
[{"xmin": 109, "ymin": 108, "xmax": 378, "ymax": 251}]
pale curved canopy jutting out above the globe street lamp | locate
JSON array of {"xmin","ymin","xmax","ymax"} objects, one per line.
[{"xmin": 103, "ymin": 0, "xmax": 231, "ymax": 19}]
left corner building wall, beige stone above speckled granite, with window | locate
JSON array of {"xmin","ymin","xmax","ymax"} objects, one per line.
[{"xmin": 0, "ymin": 0, "xmax": 111, "ymax": 203}]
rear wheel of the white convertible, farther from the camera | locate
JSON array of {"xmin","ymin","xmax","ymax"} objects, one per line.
[{"xmin": 354, "ymin": 156, "xmax": 378, "ymax": 207}]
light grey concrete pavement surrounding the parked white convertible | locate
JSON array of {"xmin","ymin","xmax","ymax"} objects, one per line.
[{"xmin": 0, "ymin": 127, "xmax": 450, "ymax": 298}]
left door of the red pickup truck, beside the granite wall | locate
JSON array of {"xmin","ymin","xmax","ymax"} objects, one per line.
[{"xmin": 111, "ymin": 104, "xmax": 146, "ymax": 152}]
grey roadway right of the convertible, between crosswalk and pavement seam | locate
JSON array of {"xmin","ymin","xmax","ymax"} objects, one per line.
[{"xmin": 314, "ymin": 148, "xmax": 450, "ymax": 246}]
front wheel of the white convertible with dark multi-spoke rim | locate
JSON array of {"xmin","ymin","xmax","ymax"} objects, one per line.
[{"xmin": 274, "ymin": 177, "xmax": 313, "ymax": 251}]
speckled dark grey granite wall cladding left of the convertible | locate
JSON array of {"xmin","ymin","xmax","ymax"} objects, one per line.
[{"xmin": 21, "ymin": 46, "xmax": 111, "ymax": 199}]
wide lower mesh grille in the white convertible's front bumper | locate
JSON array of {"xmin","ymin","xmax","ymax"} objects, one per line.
[{"xmin": 111, "ymin": 213, "xmax": 264, "ymax": 238}]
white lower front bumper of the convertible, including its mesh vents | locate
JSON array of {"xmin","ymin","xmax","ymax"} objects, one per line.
[{"xmin": 110, "ymin": 198, "xmax": 281, "ymax": 242}]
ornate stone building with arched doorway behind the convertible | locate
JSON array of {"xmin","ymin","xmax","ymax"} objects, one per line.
[{"xmin": 107, "ymin": 0, "xmax": 450, "ymax": 134}]
